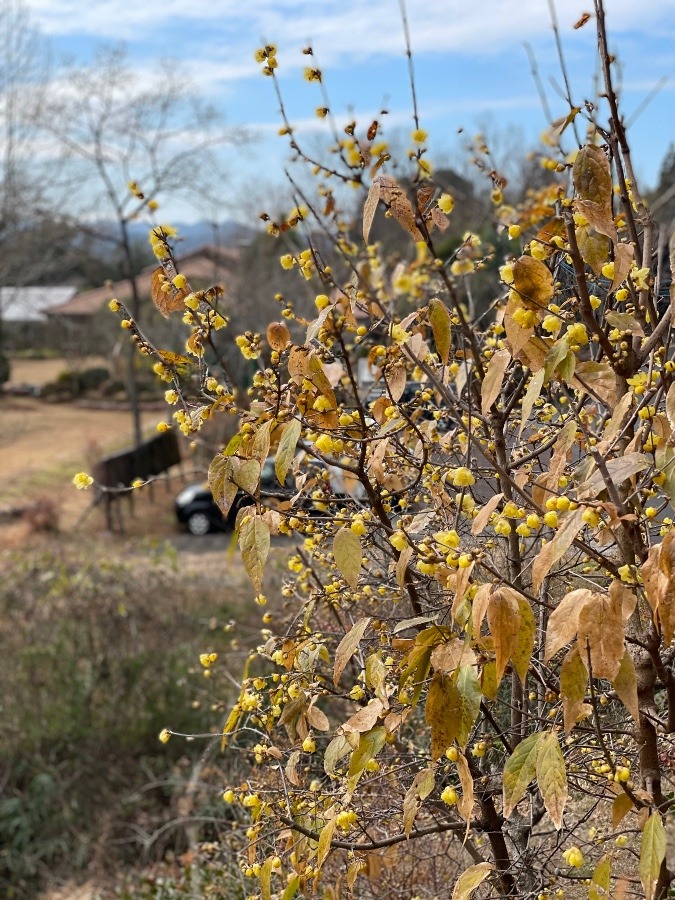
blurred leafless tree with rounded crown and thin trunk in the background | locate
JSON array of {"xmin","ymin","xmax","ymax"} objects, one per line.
[{"xmin": 40, "ymin": 47, "xmax": 242, "ymax": 443}]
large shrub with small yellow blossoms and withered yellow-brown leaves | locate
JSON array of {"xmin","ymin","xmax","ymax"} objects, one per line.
[{"xmin": 104, "ymin": 0, "xmax": 675, "ymax": 900}]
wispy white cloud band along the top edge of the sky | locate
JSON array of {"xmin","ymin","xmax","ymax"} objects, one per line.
[{"xmin": 22, "ymin": 0, "xmax": 675, "ymax": 67}]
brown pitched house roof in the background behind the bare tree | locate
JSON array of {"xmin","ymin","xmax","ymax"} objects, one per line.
[{"xmin": 49, "ymin": 244, "xmax": 240, "ymax": 316}]
